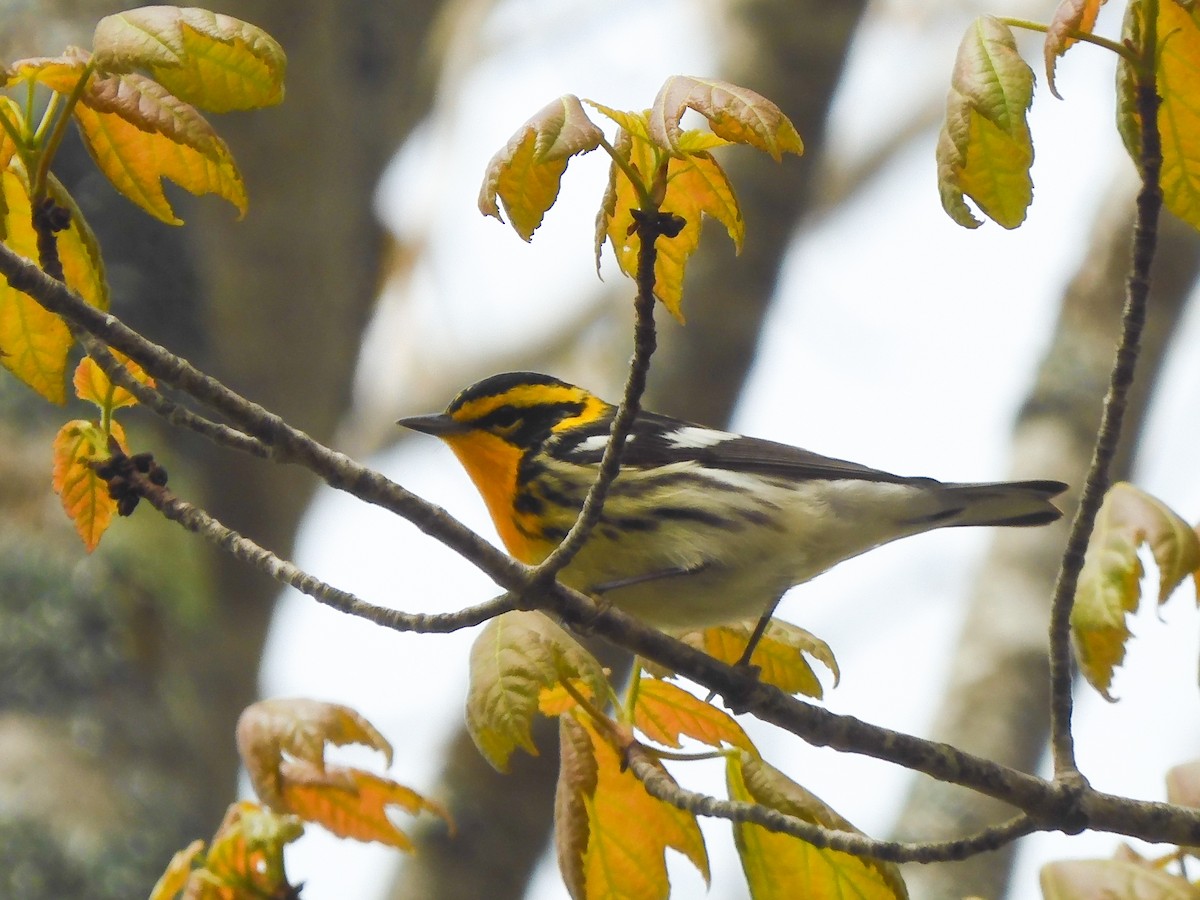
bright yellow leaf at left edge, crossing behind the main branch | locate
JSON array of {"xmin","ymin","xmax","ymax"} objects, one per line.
[{"xmin": 0, "ymin": 168, "xmax": 74, "ymax": 403}]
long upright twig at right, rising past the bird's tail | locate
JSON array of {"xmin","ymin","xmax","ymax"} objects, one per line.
[{"xmin": 1049, "ymin": 1, "xmax": 1163, "ymax": 787}]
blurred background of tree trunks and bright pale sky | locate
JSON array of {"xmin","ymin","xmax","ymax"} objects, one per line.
[{"xmin": 0, "ymin": 0, "xmax": 1200, "ymax": 900}]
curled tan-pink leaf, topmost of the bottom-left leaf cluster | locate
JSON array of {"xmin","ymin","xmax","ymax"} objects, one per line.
[{"xmin": 238, "ymin": 697, "xmax": 391, "ymax": 811}]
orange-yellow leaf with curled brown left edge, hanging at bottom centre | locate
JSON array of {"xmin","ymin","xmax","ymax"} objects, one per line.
[{"xmin": 554, "ymin": 716, "xmax": 709, "ymax": 900}]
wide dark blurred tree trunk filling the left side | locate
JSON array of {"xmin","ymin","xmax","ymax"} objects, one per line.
[{"xmin": 0, "ymin": 0, "xmax": 438, "ymax": 900}]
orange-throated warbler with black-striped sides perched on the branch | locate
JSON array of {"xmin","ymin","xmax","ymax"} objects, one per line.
[{"xmin": 397, "ymin": 372, "xmax": 1067, "ymax": 662}]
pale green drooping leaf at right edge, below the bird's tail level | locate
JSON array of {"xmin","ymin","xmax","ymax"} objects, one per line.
[{"xmin": 1070, "ymin": 481, "xmax": 1200, "ymax": 701}]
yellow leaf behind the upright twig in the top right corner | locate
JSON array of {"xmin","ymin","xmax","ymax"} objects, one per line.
[{"xmin": 1117, "ymin": 0, "xmax": 1200, "ymax": 228}]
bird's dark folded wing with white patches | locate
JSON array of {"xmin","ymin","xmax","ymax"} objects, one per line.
[{"xmin": 559, "ymin": 413, "xmax": 916, "ymax": 482}]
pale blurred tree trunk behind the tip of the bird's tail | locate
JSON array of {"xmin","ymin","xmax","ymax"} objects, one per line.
[{"xmin": 895, "ymin": 180, "xmax": 1200, "ymax": 900}]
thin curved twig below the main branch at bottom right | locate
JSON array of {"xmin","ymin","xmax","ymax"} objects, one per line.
[{"xmin": 626, "ymin": 744, "xmax": 1038, "ymax": 863}]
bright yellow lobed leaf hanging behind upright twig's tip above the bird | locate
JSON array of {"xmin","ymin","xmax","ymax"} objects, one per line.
[{"xmin": 596, "ymin": 113, "xmax": 745, "ymax": 323}]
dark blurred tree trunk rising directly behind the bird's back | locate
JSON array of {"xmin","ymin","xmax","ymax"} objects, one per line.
[{"xmin": 390, "ymin": 0, "xmax": 864, "ymax": 900}]
